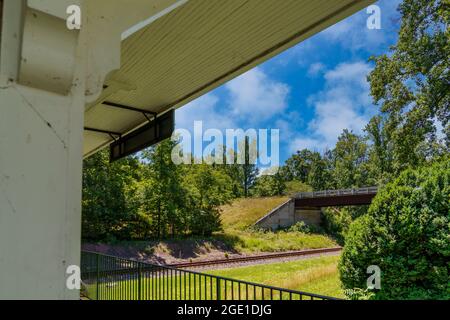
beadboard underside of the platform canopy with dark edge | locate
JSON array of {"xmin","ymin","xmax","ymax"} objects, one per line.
[{"xmin": 83, "ymin": 0, "xmax": 374, "ymax": 157}]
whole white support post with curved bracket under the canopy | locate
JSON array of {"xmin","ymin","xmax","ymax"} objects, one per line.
[{"xmin": 0, "ymin": 0, "xmax": 186, "ymax": 299}]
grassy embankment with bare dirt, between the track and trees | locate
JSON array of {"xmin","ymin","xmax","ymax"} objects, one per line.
[{"xmin": 84, "ymin": 197, "xmax": 337, "ymax": 263}]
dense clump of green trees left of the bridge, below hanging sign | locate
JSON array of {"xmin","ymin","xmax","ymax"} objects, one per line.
[{"xmin": 82, "ymin": 140, "xmax": 233, "ymax": 240}]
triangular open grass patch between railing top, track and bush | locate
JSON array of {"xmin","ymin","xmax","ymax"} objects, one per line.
[{"xmin": 208, "ymin": 256, "xmax": 345, "ymax": 298}]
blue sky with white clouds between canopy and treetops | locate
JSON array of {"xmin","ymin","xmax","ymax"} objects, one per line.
[{"xmin": 176, "ymin": 0, "xmax": 401, "ymax": 162}]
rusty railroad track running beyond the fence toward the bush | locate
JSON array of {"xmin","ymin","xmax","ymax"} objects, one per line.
[{"xmin": 167, "ymin": 247, "xmax": 342, "ymax": 268}]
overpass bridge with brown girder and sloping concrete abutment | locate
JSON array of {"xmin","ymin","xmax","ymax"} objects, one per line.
[{"xmin": 255, "ymin": 187, "xmax": 378, "ymax": 230}]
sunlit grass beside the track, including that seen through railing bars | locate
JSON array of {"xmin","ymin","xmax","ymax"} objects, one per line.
[{"xmin": 84, "ymin": 256, "xmax": 344, "ymax": 300}]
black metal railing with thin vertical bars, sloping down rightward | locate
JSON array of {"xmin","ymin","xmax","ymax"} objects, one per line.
[{"xmin": 81, "ymin": 251, "xmax": 337, "ymax": 300}]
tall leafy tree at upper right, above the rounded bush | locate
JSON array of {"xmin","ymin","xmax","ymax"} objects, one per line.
[{"xmin": 369, "ymin": 0, "xmax": 450, "ymax": 174}]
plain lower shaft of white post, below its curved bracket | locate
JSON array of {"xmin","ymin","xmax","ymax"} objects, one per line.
[{"xmin": 0, "ymin": 85, "xmax": 84, "ymax": 299}]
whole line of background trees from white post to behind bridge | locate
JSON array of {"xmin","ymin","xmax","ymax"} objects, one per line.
[{"xmin": 83, "ymin": 124, "xmax": 404, "ymax": 240}]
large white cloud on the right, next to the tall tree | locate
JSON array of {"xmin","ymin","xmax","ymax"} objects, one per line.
[{"xmin": 291, "ymin": 62, "xmax": 377, "ymax": 151}]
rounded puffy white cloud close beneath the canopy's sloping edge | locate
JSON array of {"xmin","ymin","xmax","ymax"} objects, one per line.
[{"xmin": 225, "ymin": 68, "xmax": 290, "ymax": 124}]
